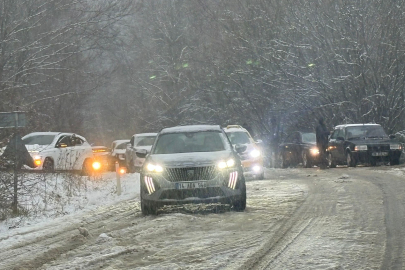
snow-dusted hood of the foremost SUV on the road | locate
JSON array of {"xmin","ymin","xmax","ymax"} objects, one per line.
[{"xmin": 147, "ymin": 151, "xmax": 232, "ymax": 167}]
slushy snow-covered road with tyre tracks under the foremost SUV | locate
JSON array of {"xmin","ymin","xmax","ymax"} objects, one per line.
[{"xmin": 0, "ymin": 167, "xmax": 405, "ymax": 269}]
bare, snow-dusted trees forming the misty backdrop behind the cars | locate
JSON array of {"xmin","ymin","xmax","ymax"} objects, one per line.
[{"xmin": 0, "ymin": 0, "xmax": 405, "ymax": 144}]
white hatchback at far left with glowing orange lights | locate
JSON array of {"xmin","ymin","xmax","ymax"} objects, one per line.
[{"xmin": 22, "ymin": 132, "xmax": 93, "ymax": 174}]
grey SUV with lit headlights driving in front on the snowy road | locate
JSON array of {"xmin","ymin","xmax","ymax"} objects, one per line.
[{"xmin": 136, "ymin": 125, "xmax": 246, "ymax": 214}]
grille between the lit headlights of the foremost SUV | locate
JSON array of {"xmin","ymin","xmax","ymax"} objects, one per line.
[{"xmin": 163, "ymin": 166, "xmax": 217, "ymax": 182}]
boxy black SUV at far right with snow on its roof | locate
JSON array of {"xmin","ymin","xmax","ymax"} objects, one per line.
[{"xmin": 328, "ymin": 124, "xmax": 402, "ymax": 168}]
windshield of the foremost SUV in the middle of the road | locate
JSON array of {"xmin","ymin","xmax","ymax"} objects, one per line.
[{"xmin": 153, "ymin": 131, "xmax": 225, "ymax": 154}]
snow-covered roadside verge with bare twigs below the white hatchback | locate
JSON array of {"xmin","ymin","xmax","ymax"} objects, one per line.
[{"xmin": 0, "ymin": 172, "xmax": 139, "ymax": 235}]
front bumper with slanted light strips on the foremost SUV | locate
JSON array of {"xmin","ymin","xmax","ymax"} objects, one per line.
[{"xmin": 141, "ymin": 173, "xmax": 244, "ymax": 207}]
